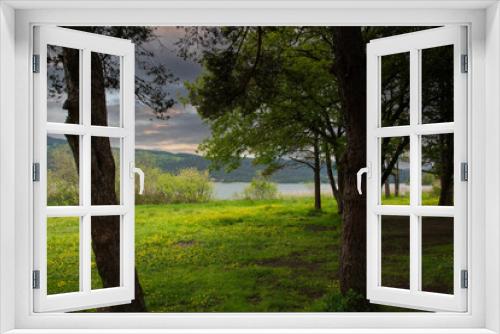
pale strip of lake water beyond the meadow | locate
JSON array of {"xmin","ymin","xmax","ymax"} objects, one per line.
[{"xmin": 214, "ymin": 182, "xmax": 332, "ymax": 199}]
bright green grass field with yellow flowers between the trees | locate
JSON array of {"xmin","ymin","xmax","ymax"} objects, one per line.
[{"xmin": 48, "ymin": 197, "xmax": 452, "ymax": 312}]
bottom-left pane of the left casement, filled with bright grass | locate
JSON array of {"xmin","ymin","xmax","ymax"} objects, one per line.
[{"xmin": 47, "ymin": 217, "xmax": 80, "ymax": 295}]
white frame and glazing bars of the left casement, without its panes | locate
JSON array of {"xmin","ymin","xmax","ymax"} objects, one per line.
[{"xmin": 33, "ymin": 26, "xmax": 135, "ymax": 312}]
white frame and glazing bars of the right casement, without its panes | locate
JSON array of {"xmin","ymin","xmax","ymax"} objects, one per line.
[{"xmin": 366, "ymin": 26, "xmax": 469, "ymax": 312}]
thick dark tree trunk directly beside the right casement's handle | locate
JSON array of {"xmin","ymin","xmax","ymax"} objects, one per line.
[{"xmin": 332, "ymin": 27, "xmax": 366, "ymax": 300}]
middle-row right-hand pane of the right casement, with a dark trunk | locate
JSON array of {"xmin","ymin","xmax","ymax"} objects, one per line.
[{"xmin": 422, "ymin": 133, "xmax": 454, "ymax": 206}]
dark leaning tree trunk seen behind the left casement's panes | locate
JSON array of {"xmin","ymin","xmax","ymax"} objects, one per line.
[{"xmin": 63, "ymin": 48, "xmax": 146, "ymax": 312}]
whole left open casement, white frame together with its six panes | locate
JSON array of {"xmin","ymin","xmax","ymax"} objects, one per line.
[{"xmin": 33, "ymin": 27, "xmax": 140, "ymax": 312}]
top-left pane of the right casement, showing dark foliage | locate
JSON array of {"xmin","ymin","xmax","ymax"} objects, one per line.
[{"xmin": 380, "ymin": 52, "xmax": 410, "ymax": 126}]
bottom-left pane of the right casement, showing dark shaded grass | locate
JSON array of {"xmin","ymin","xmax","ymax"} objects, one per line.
[{"xmin": 381, "ymin": 216, "xmax": 410, "ymax": 289}]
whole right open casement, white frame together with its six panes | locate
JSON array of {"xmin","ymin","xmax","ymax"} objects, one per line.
[{"xmin": 360, "ymin": 27, "xmax": 468, "ymax": 312}]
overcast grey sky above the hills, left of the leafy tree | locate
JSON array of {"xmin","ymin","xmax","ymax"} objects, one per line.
[{"xmin": 47, "ymin": 27, "xmax": 214, "ymax": 153}]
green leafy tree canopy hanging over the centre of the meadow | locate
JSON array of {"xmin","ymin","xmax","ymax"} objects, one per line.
[{"xmin": 186, "ymin": 27, "xmax": 344, "ymax": 180}]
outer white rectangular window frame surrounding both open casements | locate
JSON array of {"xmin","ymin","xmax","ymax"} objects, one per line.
[{"xmin": 0, "ymin": 0, "xmax": 500, "ymax": 333}]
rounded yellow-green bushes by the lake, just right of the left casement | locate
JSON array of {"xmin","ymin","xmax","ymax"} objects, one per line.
[{"xmin": 136, "ymin": 168, "xmax": 213, "ymax": 204}]
